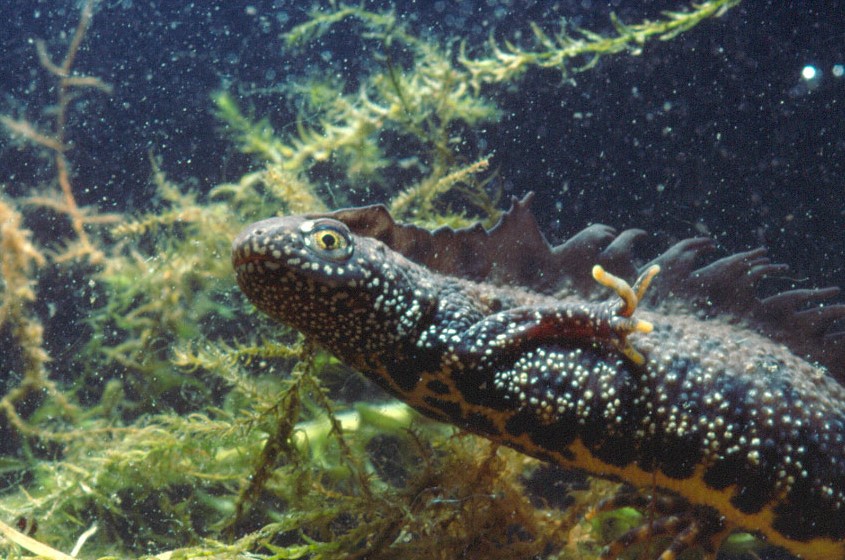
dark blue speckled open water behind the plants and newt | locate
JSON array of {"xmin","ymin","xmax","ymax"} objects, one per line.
[{"xmin": 0, "ymin": 0, "xmax": 845, "ymax": 285}]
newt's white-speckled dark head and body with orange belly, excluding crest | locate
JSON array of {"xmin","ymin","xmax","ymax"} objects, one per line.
[{"xmin": 233, "ymin": 216, "xmax": 845, "ymax": 560}]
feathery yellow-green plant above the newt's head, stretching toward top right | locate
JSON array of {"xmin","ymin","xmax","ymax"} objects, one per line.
[{"xmin": 214, "ymin": 0, "xmax": 738, "ymax": 226}]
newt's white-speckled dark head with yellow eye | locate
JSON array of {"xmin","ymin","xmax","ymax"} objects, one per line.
[{"xmin": 232, "ymin": 216, "xmax": 438, "ymax": 356}]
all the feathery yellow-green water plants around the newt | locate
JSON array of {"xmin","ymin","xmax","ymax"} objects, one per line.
[{"xmin": 0, "ymin": 0, "xmax": 737, "ymax": 559}]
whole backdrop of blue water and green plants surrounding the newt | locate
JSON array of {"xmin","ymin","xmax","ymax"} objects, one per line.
[{"xmin": 0, "ymin": 0, "xmax": 845, "ymax": 558}]
